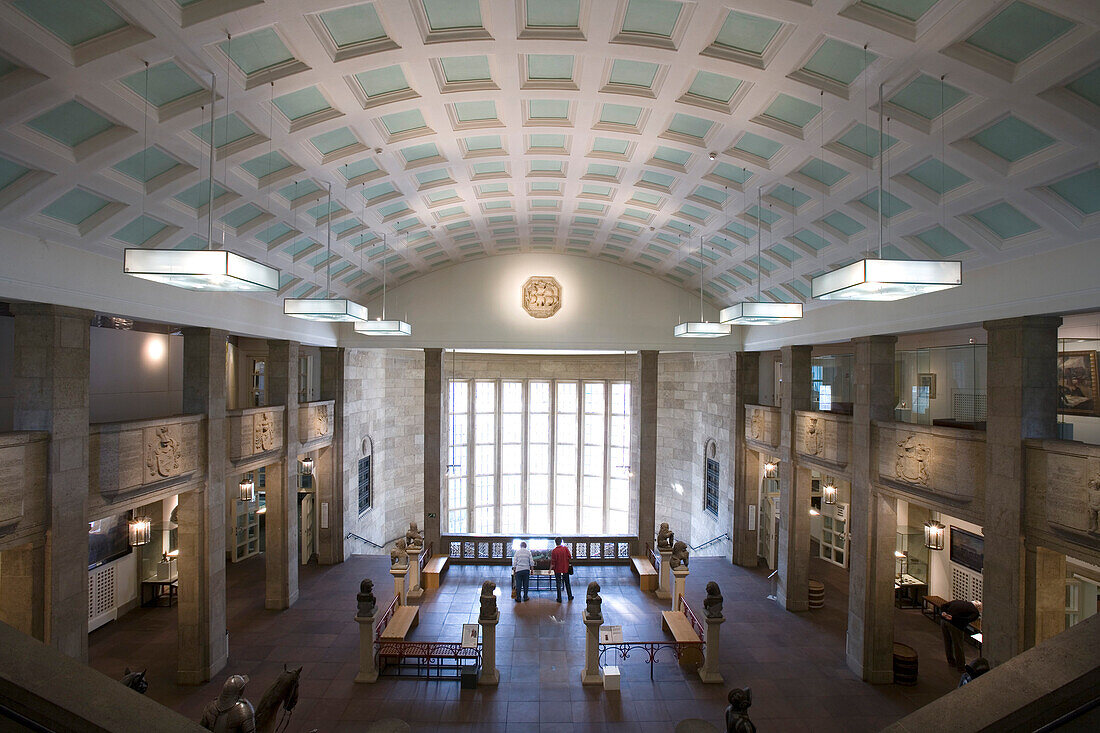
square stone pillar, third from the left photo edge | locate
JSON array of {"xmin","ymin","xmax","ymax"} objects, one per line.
[{"xmin": 264, "ymin": 340, "xmax": 301, "ymax": 611}]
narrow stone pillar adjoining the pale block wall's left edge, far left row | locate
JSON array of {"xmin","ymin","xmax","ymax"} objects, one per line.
[{"xmin": 317, "ymin": 347, "xmax": 343, "ymax": 565}]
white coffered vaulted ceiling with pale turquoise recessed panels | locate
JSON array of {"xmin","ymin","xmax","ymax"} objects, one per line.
[{"xmin": 0, "ymin": 0, "xmax": 1100, "ymax": 306}]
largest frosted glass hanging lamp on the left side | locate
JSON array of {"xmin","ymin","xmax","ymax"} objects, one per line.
[{"xmin": 122, "ymin": 249, "xmax": 278, "ymax": 292}]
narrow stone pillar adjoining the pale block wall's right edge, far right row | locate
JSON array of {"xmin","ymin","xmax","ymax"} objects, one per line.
[{"xmin": 729, "ymin": 351, "xmax": 760, "ymax": 568}]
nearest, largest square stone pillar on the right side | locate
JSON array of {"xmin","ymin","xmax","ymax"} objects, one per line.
[{"xmin": 981, "ymin": 316, "xmax": 1062, "ymax": 665}]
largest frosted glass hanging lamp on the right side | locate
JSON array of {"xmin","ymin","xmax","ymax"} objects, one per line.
[{"xmin": 810, "ymin": 260, "xmax": 963, "ymax": 300}]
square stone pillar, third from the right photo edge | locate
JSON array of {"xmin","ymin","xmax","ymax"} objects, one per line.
[{"xmin": 776, "ymin": 346, "xmax": 812, "ymax": 611}]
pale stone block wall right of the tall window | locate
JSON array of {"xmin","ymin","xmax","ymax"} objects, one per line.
[{"xmin": 656, "ymin": 353, "xmax": 734, "ymax": 555}]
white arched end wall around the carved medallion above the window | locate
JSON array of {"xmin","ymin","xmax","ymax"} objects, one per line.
[{"xmin": 340, "ymin": 254, "xmax": 740, "ymax": 351}]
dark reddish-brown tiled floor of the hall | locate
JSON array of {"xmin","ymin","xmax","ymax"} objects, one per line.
[{"xmin": 89, "ymin": 556, "xmax": 974, "ymax": 733}]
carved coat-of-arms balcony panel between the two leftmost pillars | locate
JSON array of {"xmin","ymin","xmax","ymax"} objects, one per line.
[{"xmin": 88, "ymin": 415, "xmax": 206, "ymax": 503}]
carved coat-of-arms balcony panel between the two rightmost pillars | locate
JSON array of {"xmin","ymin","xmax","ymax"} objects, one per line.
[{"xmin": 872, "ymin": 423, "xmax": 986, "ymax": 510}]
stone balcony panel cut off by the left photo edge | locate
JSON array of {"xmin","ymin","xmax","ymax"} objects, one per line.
[{"xmin": 0, "ymin": 433, "xmax": 50, "ymax": 548}]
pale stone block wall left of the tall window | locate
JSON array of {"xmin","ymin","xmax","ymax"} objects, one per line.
[{"xmin": 343, "ymin": 349, "xmax": 424, "ymax": 555}]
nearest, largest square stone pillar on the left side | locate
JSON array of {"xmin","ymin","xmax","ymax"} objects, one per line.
[{"xmin": 11, "ymin": 303, "xmax": 94, "ymax": 661}]
